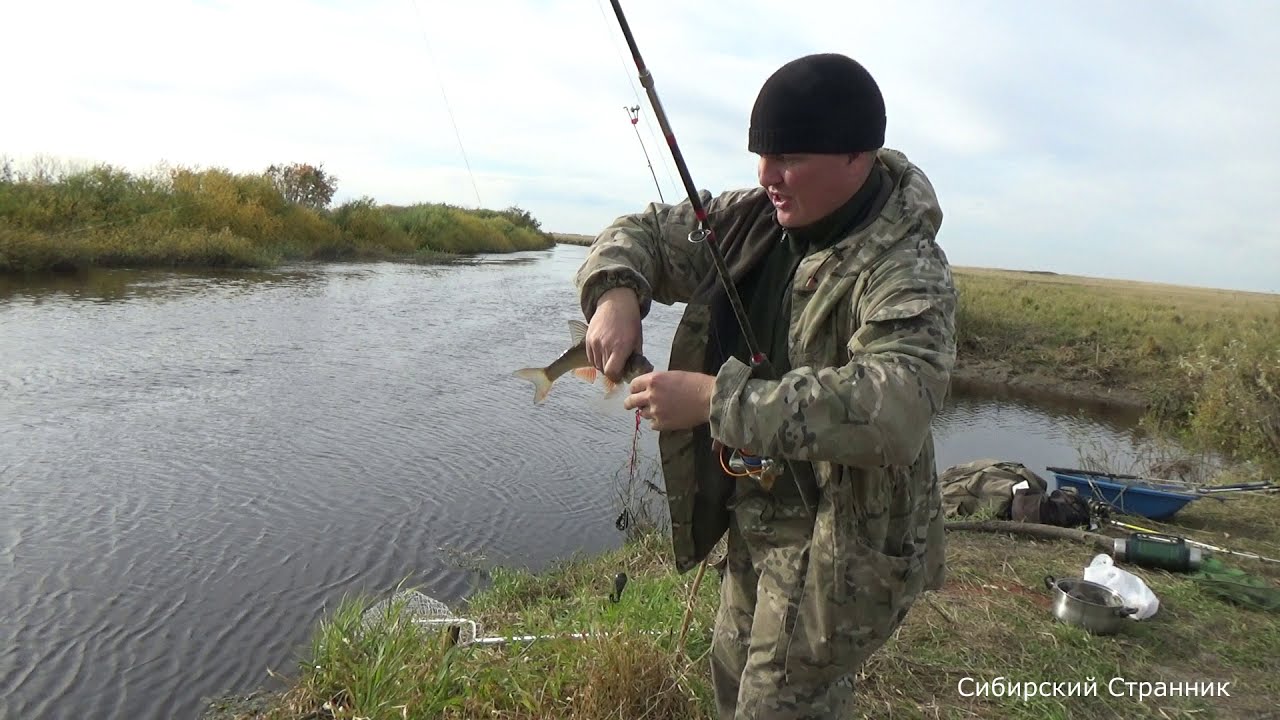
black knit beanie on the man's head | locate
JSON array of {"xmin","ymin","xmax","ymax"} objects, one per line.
[{"xmin": 746, "ymin": 53, "xmax": 884, "ymax": 155}]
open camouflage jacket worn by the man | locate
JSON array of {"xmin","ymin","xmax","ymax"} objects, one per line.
[{"xmin": 575, "ymin": 149, "xmax": 956, "ymax": 587}]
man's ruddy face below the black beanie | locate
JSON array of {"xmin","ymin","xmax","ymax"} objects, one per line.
[{"xmin": 758, "ymin": 152, "xmax": 865, "ymax": 228}]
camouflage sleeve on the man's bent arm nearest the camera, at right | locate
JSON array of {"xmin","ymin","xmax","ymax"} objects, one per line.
[{"xmin": 710, "ymin": 238, "xmax": 956, "ymax": 468}]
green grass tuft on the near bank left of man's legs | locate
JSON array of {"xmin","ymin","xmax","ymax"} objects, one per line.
[{"xmin": 232, "ymin": 533, "xmax": 716, "ymax": 720}]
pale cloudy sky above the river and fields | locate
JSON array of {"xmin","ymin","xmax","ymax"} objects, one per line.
[{"xmin": 0, "ymin": 0, "xmax": 1280, "ymax": 292}]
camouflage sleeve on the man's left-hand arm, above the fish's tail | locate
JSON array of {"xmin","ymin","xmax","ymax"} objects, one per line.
[{"xmin": 575, "ymin": 190, "xmax": 750, "ymax": 320}]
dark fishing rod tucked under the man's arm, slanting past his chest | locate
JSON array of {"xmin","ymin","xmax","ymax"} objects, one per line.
[{"xmin": 609, "ymin": 0, "xmax": 814, "ymax": 515}]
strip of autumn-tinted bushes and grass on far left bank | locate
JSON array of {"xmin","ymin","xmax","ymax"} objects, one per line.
[{"xmin": 0, "ymin": 159, "xmax": 554, "ymax": 273}]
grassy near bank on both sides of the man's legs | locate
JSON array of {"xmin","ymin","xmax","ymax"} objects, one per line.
[{"xmin": 206, "ymin": 486, "xmax": 1280, "ymax": 720}]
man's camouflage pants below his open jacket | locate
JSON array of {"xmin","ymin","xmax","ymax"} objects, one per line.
[{"xmin": 712, "ymin": 484, "xmax": 923, "ymax": 720}]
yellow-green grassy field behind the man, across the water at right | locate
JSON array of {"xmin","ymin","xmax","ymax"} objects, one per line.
[{"xmin": 956, "ymin": 268, "xmax": 1280, "ymax": 475}]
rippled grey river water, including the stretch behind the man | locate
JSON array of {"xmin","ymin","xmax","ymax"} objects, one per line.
[{"xmin": 0, "ymin": 246, "xmax": 1157, "ymax": 720}]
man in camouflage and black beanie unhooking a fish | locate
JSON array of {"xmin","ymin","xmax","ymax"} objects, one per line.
[{"xmin": 576, "ymin": 54, "xmax": 956, "ymax": 720}]
